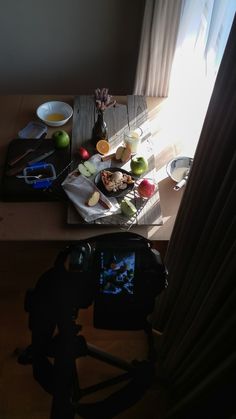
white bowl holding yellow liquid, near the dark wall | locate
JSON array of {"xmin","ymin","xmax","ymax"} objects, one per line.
[{"xmin": 36, "ymin": 100, "xmax": 73, "ymax": 127}]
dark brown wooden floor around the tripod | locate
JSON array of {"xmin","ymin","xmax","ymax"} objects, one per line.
[{"xmin": 0, "ymin": 242, "xmax": 166, "ymax": 419}]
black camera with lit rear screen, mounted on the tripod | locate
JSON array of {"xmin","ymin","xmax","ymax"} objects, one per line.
[{"xmin": 67, "ymin": 233, "xmax": 167, "ymax": 330}]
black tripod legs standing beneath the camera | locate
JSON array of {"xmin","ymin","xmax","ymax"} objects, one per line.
[{"xmin": 18, "ymin": 308, "xmax": 156, "ymax": 419}]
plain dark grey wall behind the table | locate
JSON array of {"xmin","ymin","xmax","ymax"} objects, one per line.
[{"xmin": 0, "ymin": 0, "xmax": 144, "ymax": 94}]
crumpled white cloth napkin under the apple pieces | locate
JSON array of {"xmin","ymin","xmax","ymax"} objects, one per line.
[{"xmin": 62, "ymin": 156, "xmax": 120, "ymax": 223}]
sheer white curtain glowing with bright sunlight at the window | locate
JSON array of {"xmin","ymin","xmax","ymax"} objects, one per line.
[{"xmin": 166, "ymin": 0, "xmax": 236, "ymax": 156}]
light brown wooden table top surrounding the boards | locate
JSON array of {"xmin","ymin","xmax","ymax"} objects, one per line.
[{"xmin": 0, "ymin": 95, "xmax": 183, "ymax": 241}]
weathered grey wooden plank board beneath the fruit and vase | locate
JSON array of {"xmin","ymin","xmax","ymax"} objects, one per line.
[{"xmin": 67, "ymin": 95, "xmax": 162, "ymax": 229}]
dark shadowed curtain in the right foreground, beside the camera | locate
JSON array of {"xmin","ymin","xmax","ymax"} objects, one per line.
[{"xmin": 153, "ymin": 13, "xmax": 236, "ymax": 419}]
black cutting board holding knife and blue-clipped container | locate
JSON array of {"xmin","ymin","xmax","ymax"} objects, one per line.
[{"xmin": 1, "ymin": 138, "xmax": 70, "ymax": 202}]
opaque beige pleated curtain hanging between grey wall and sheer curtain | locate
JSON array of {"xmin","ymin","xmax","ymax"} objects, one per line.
[{"xmin": 134, "ymin": 0, "xmax": 182, "ymax": 97}]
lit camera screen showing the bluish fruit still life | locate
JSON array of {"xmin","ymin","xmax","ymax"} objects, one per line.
[{"xmin": 99, "ymin": 250, "xmax": 135, "ymax": 296}]
